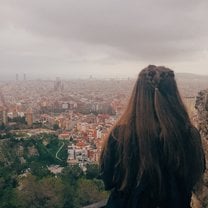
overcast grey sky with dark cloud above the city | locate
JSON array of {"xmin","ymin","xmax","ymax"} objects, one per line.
[{"xmin": 0, "ymin": 0, "xmax": 208, "ymax": 78}]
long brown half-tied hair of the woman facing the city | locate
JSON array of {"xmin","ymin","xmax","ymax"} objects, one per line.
[{"xmin": 100, "ymin": 65, "xmax": 203, "ymax": 193}]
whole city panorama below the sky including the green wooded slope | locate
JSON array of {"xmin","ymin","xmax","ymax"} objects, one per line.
[{"xmin": 0, "ymin": 74, "xmax": 208, "ymax": 207}]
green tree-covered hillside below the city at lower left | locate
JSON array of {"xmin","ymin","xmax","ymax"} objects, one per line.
[{"xmin": 0, "ymin": 134, "xmax": 107, "ymax": 208}]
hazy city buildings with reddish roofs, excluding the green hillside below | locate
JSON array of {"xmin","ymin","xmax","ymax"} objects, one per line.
[{"xmin": 0, "ymin": 74, "xmax": 206, "ymax": 167}]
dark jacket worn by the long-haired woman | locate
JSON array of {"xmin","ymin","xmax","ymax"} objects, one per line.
[{"xmin": 101, "ymin": 128, "xmax": 205, "ymax": 208}]
